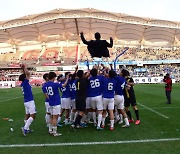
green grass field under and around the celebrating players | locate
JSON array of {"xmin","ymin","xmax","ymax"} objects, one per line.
[{"xmin": 0, "ymin": 84, "xmax": 180, "ymax": 154}]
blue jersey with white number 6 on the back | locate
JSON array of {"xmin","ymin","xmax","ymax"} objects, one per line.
[{"xmin": 103, "ymin": 77, "xmax": 117, "ymax": 98}]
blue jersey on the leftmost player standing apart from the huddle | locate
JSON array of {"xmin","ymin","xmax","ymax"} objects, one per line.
[{"xmin": 21, "ymin": 79, "xmax": 34, "ymax": 103}]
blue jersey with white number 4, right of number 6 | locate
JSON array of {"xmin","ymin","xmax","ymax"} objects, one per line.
[{"xmin": 115, "ymin": 76, "xmax": 126, "ymax": 95}]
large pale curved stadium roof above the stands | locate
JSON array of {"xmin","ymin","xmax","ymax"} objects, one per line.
[{"xmin": 0, "ymin": 8, "xmax": 180, "ymax": 48}]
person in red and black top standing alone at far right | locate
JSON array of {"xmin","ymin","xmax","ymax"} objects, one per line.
[{"xmin": 163, "ymin": 73, "xmax": 172, "ymax": 104}]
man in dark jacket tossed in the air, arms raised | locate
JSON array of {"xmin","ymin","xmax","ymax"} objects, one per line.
[{"xmin": 80, "ymin": 32, "xmax": 113, "ymax": 58}]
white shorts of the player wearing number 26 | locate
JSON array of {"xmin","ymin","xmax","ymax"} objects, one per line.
[{"xmin": 90, "ymin": 95, "xmax": 103, "ymax": 111}]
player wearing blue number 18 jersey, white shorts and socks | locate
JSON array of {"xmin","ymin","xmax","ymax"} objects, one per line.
[{"xmin": 45, "ymin": 72, "xmax": 69, "ymax": 136}]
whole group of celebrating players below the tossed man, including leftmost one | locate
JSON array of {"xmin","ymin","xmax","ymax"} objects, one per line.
[{"xmin": 19, "ymin": 64, "xmax": 140, "ymax": 136}]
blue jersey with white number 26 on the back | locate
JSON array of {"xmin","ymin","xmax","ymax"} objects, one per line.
[{"xmin": 89, "ymin": 75, "xmax": 103, "ymax": 97}]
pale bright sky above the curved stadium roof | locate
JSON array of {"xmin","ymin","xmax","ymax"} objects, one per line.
[{"xmin": 0, "ymin": 0, "xmax": 180, "ymax": 22}]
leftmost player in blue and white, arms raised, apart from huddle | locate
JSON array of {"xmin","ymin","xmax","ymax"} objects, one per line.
[{"xmin": 19, "ymin": 64, "xmax": 36, "ymax": 136}]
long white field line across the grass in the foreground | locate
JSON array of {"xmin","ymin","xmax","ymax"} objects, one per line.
[{"xmin": 0, "ymin": 138, "xmax": 180, "ymax": 148}]
